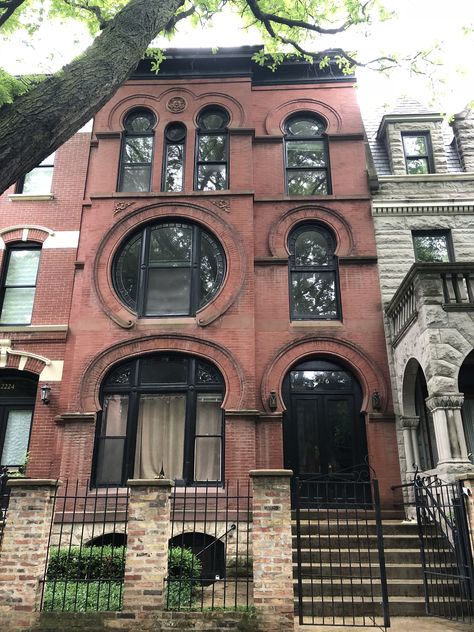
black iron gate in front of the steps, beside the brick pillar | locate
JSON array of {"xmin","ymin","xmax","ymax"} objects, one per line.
[{"xmin": 294, "ymin": 478, "xmax": 390, "ymax": 627}]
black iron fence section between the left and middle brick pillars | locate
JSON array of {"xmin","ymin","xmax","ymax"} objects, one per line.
[{"xmin": 41, "ymin": 481, "xmax": 129, "ymax": 612}]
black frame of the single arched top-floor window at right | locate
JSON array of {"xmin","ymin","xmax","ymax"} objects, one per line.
[{"xmin": 283, "ymin": 112, "xmax": 332, "ymax": 198}]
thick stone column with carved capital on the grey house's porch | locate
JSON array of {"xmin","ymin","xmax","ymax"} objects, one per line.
[{"xmin": 426, "ymin": 393, "xmax": 471, "ymax": 469}]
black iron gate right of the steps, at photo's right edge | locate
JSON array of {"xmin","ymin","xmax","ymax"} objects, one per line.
[{"xmin": 414, "ymin": 477, "xmax": 474, "ymax": 622}]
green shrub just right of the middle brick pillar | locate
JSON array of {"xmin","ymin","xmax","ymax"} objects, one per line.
[{"xmin": 166, "ymin": 546, "xmax": 202, "ymax": 610}]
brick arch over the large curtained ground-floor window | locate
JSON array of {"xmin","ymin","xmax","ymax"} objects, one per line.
[{"xmin": 79, "ymin": 334, "xmax": 246, "ymax": 411}]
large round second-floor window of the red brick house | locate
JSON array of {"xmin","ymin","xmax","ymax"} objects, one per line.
[{"xmin": 113, "ymin": 221, "xmax": 225, "ymax": 316}]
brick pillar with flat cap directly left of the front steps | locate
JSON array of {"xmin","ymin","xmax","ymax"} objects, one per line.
[{"xmin": 250, "ymin": 470, "xmax": 294, "ymax": 632}]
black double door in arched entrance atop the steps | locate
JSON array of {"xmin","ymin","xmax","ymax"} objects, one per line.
[{"xmin": 283, "ymin": 359, "xmax": 367, "ymax": 478}]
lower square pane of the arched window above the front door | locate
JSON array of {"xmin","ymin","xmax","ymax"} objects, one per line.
[{"xmin": 291, "ymin": 272, "xmax": 337, "ymax": 318}]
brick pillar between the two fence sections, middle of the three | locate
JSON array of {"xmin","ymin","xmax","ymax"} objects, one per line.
[{"xmin": 123, "ymin": 479, "xmax": 174, "ymax": 613}]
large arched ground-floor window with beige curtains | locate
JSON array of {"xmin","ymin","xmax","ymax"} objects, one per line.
[{"xmin": 95, "ymin": 354, "xmax": 224, "ymax": 486}]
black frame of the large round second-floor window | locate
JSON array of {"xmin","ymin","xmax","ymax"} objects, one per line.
[{"xmin": 112, "ymin": 218, "xmax": 227, "ymax": 318}]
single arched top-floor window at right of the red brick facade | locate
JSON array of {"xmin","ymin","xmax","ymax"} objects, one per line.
[{"xmin": 285, "ymin": 114, "xmax": 331, "ymax": 195}]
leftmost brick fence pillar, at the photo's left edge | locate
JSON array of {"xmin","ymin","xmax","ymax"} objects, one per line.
[{"xmin": 0, "ymin": 478, "xmax": 58, "ymax": 631}]
